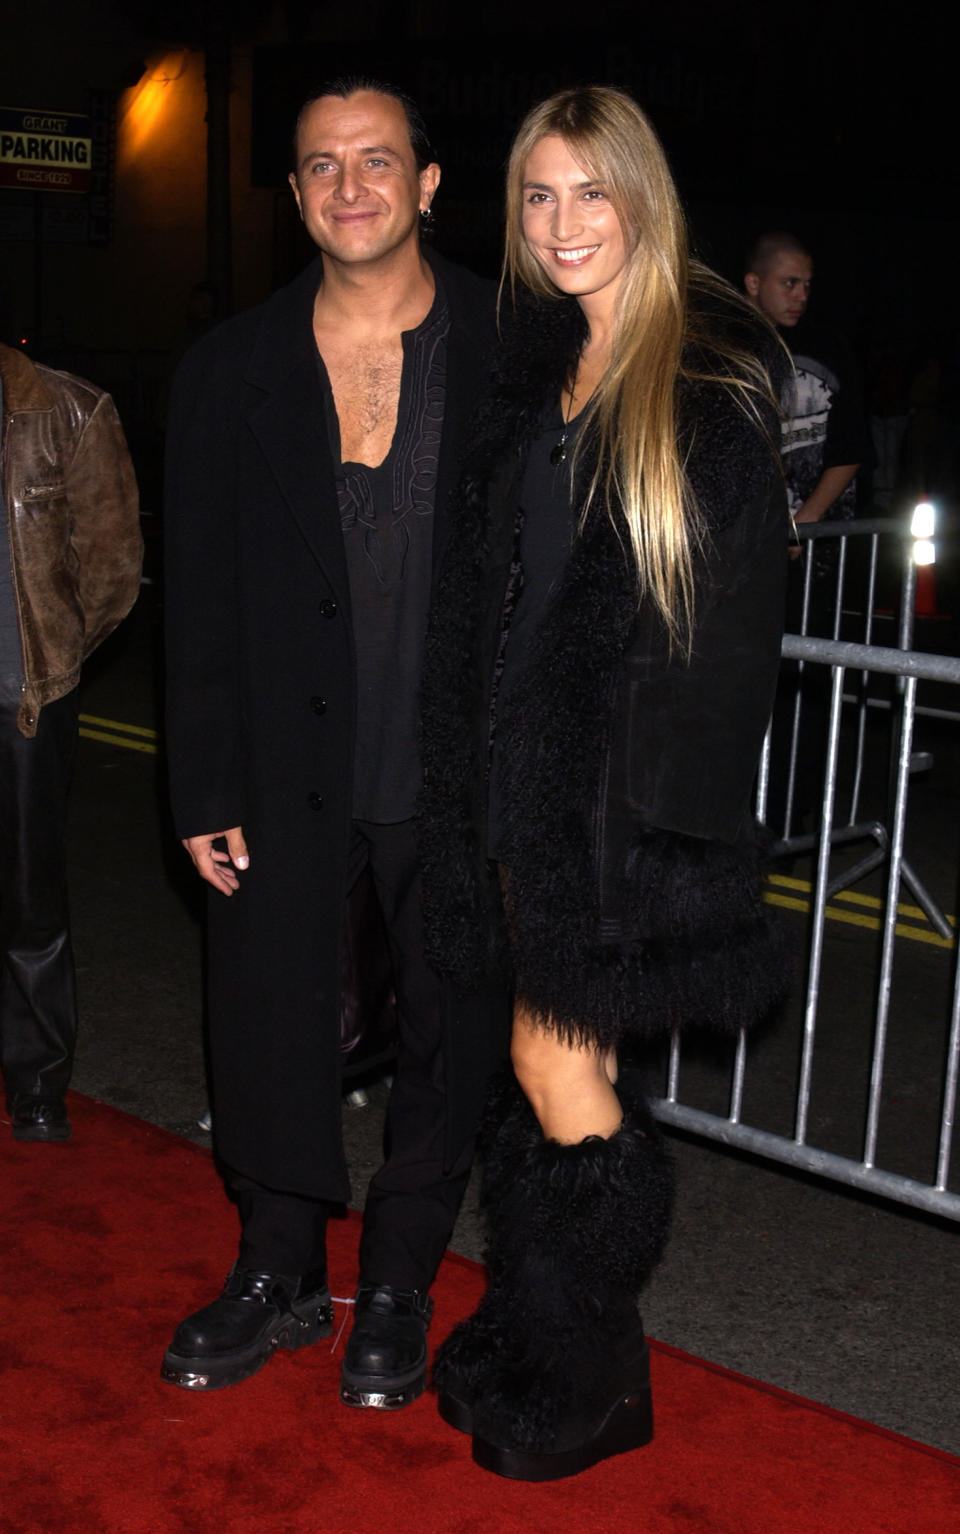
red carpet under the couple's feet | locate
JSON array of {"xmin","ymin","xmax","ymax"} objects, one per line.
[{"xmin": 0, "ymin": 1097, "xmax": 960, "ymax": 1534}]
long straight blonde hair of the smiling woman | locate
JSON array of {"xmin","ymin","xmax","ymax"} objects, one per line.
[{"xmin": 501, "ymin": 86, "xmax": 771, "ymax": 646}]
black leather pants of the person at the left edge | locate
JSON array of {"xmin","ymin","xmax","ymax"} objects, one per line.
[{"xmin": 0, "ymin": 689, "xmax": 77, "ymax": 1100}]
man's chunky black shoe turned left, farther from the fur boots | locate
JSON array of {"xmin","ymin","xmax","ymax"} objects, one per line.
[{"xmin": 161, "ymin": 1262, "xmax": 333, "ymax": 1390}]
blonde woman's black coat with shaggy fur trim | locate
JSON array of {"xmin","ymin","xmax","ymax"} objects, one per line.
[{"xmin": 420, "ymin": 292, "xmax": 788, "ymax": 1046}]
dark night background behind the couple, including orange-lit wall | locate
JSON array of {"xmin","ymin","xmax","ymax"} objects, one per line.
[{"xmin": 0, "ymin": 0, "xmax": 960, "ymax": 552}]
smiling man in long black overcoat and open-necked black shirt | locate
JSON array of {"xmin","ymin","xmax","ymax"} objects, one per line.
[{"xmin": 164, "ymin": 81, "xmax": 508, "ymax": 1407}]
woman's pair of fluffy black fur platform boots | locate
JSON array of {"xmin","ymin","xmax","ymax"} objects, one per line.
[{"xmin": 434, "ymin": 1078, "xmax": 673, "ymax": 1480}]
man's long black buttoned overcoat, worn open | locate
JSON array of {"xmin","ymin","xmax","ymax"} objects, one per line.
[{"xmin": 164, "ymin": 253, "xmax": 495, "ymax": 1200}]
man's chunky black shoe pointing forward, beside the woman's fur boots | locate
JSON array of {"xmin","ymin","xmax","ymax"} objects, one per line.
[{"xmin": 340, "ymin": 1284, "xmax": 434, "ymax": 1411}]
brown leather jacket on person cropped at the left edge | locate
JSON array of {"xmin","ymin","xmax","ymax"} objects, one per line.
[{"xmin": 0, "ymin": 345, "xmax": 143, "ymax": 736}]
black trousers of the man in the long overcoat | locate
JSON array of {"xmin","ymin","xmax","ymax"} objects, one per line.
[{"xmin": 227, "ymin": 821, "xmax": 472, "ymax": 1290}]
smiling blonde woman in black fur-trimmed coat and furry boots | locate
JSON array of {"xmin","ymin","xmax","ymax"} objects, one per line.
[{"xmin": 422, "ymin": 87, "xmax": 787, "ymax": 1480}]
